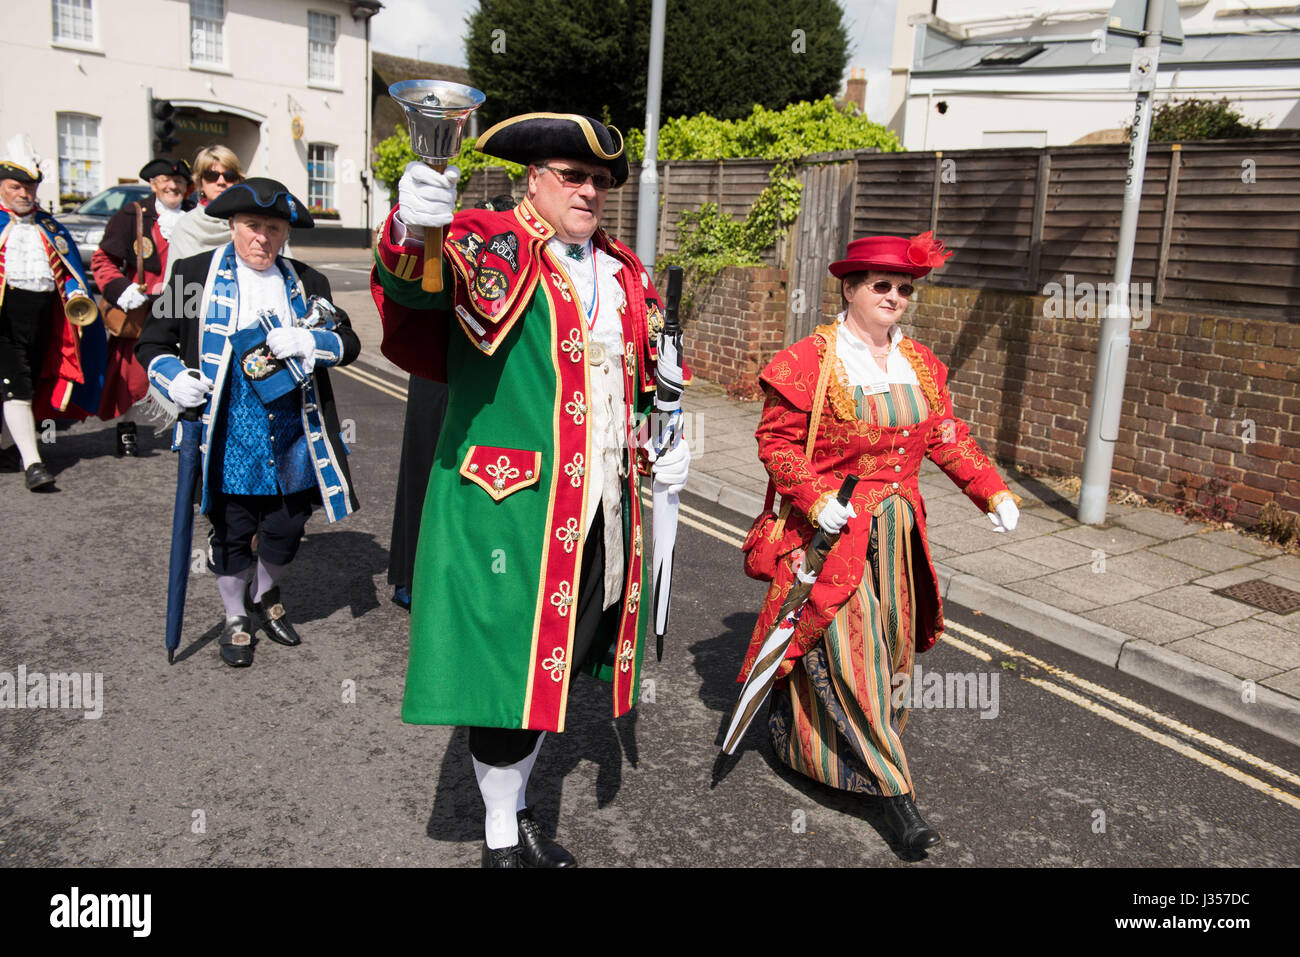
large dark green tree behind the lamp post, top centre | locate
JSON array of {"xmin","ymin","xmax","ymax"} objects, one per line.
[{"xmin": 465, "ymin": 0, "xmax": 849, "ymax": 130}]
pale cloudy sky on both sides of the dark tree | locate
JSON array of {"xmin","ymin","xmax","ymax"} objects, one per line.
[{"xmin": 371, "ymin": 0, "xmax": 896, "ymax": 122}]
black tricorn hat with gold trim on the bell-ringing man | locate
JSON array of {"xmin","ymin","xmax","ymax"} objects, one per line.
[{"xmin": 475, "ymin": 113, "xmax": 628, "ymax": 186}]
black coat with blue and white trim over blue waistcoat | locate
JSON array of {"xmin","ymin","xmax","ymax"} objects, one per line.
[{"xmin": 135, "ymin": 247, "xmax": 361, "ymax": 521}]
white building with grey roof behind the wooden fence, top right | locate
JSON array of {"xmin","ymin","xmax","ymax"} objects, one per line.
[{"xmin": 891, "ymin": 0, "xmax": 1300, "ymax": 150}]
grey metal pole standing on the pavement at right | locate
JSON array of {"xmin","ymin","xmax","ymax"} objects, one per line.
[{"xmin": 1078, "ymin": 0, "xmax": 1166, "ymax": 525}]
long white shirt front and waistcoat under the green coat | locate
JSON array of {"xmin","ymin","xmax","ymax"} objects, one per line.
[{"xmin": 547, "ymin": 237, "xmax": 627, "ymax": 609}]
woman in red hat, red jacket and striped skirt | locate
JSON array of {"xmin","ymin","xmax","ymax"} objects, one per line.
[{"xmin": 741, "ymin": 233, "xmax": 1019, "ymax": 852}]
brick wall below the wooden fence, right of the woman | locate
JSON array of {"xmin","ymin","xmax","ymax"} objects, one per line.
[{"xmin": 878, "ymin": 280, "xmax": 1300, "ymax": 524}]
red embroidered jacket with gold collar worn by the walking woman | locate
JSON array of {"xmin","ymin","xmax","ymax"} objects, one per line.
[{"xmin": 741, "ymin": 324, "xmax": 1019, "ymax": 680}]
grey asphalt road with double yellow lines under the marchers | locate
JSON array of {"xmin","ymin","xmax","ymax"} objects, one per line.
[{"xmin": 0, "ymin": 361, "xmax": 1300, "ymax": 873}]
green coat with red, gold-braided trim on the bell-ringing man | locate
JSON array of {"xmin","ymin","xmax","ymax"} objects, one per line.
[{"xmin": 371, "ymin": 200, "xmax": 681, "ymax": 731}]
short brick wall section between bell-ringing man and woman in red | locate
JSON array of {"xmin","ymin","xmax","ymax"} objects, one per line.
[{"xmin": 676, "ymin": 267, "xmax": 787, "ymax": 391}]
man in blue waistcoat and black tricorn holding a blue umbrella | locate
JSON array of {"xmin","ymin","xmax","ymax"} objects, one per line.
[{"xmin": 135, "ymin": 177, "xmax": 361, "ymax": 667}]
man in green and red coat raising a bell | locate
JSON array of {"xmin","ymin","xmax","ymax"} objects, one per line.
[{"xmin": 371, "ymin": 113, "xmax": 690, "ymax": 867}]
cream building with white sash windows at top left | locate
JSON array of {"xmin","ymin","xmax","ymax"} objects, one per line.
[{"xmin": 0, "ymin": 0, "xmax": 380, "ymax": 226}]
